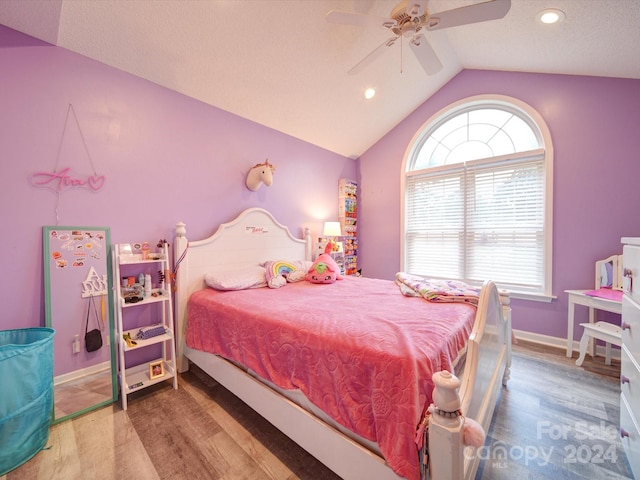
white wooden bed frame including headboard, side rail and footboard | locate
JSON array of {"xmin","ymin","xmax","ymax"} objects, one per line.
[{"xmin": 174, "ymin": 208, "xmax": 511, "ymax": 480}]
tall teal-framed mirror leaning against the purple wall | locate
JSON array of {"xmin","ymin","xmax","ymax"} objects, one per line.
[{"xmin": 43, "ymin": 226, "xmax": 118, "ymax": 423}]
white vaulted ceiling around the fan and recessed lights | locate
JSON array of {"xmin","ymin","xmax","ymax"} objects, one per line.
[{"xmin": 0, "ymin": 0, "xmax": 640, "ymax": 158}]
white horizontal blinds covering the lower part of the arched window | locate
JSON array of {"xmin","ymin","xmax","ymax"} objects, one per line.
[{"xmin": 405, "ymin": 152, "xmax": 545, "ymax": 292}]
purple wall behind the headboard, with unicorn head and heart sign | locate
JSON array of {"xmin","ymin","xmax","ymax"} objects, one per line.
[{"xmin": 0, "ymin": 25, "xmax": 356, "ymax": 340}]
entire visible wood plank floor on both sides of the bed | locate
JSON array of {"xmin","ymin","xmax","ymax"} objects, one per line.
[{"xmin": 0, "ymin": 343, "xmax": 633, "ymax": 480}]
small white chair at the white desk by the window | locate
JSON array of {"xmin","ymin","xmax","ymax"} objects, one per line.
[{"xmin": 576, "ymin": 255, "xmax": 622, "ymax": 366}]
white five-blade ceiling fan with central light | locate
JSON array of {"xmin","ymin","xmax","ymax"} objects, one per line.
[{"xmin": 326, "ymin": 0, "xmax": 511, "ymax": 75}]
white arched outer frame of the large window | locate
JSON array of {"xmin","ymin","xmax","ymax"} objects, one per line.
[{"xmin": 400, "ymin": 94, "xmax": 554, "ymax": 302}]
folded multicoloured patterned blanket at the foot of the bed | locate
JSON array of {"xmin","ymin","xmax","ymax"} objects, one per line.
[{"xmin": 396, "ymin": 272, "xmax": 480, "ymax": 305}]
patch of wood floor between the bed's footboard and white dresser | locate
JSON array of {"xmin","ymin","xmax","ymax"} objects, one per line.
[{"xmin": 476, "ymin": 342, "xmax": 633, "ymax": 480}]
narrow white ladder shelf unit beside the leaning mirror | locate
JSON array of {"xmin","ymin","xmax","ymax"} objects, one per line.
[{"xmin": 113, "ymin": 243, "xmax": 178, "ymax": 410}]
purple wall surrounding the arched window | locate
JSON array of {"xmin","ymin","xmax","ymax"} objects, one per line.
[{"xmin": 358, "ymin": 70, "xmax": 640, "ymax": 344}]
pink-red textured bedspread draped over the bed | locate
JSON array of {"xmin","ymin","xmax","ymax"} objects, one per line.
[{"xmin": 186, "ymin": 277, "xmax": 476, "ymax": 480}]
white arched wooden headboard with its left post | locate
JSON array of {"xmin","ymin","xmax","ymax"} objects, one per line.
[{"xmin": 174, "ymin": 208, "xmax": 312, "ymax": 371}]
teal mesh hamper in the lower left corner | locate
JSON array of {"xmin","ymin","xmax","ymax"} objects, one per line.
[{"xmin": 0, "ymin": 328, "xmax": 54, "ymax": 476}]
